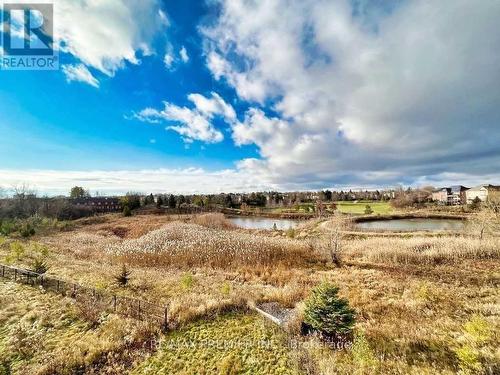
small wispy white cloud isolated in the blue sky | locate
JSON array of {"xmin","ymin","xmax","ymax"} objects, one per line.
[{"xmin": 134, "ymin": 92, "xmax": 236, "ymax": 143}]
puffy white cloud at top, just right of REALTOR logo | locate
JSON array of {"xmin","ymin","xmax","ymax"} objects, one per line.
[{"xmin": 11, "ymin": 0, "xmax": 163, "ymax": 76}]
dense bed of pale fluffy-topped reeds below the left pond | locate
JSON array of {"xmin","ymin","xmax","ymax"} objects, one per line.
[{"xmin": 107, "ymin": 223, "xmax": 319, "ymax": 268}]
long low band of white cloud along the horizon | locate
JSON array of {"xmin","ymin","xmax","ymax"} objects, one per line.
[{"xmin": 0, "ymin": 167, "xmax": 500, "ymax": 195}]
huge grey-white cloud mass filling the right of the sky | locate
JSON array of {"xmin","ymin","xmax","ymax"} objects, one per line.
[{"xmin": 203, "ymin": 0, "xmax": 500, "ymax": 187}]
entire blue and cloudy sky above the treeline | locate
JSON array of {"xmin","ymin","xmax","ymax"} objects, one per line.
[{"xmin": 0, "ymin": 0, "xmax": 500, "ymax": 194}]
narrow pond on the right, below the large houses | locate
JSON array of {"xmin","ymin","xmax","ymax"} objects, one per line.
[{"xmin": 356, "ymin": 218, "xmax": 465, "ymax": 232}]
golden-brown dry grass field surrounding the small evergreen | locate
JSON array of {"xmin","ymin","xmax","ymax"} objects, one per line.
[{"xmin": 0, "ymin": 215, "xmax": 500, "ymax": 375}]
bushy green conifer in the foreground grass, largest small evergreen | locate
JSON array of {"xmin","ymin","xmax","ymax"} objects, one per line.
[{"xmin": 304, "ymin": 282, "xmax": 355, "ymax": 335}]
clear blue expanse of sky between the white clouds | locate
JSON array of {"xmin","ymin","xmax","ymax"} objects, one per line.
[{"xmin": 0, "ymin": 2, "xmax": 256, "ymax": 170}]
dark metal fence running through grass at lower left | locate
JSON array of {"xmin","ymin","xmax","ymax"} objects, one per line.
[{"xmin": 0, "ymin": 265, "xmax": 168, "ymax": 330}]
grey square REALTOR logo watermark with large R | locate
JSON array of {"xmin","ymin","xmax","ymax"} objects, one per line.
[{"xmin": 0, "ymin": 3, "xmax": 59, "ymax": 70}]
